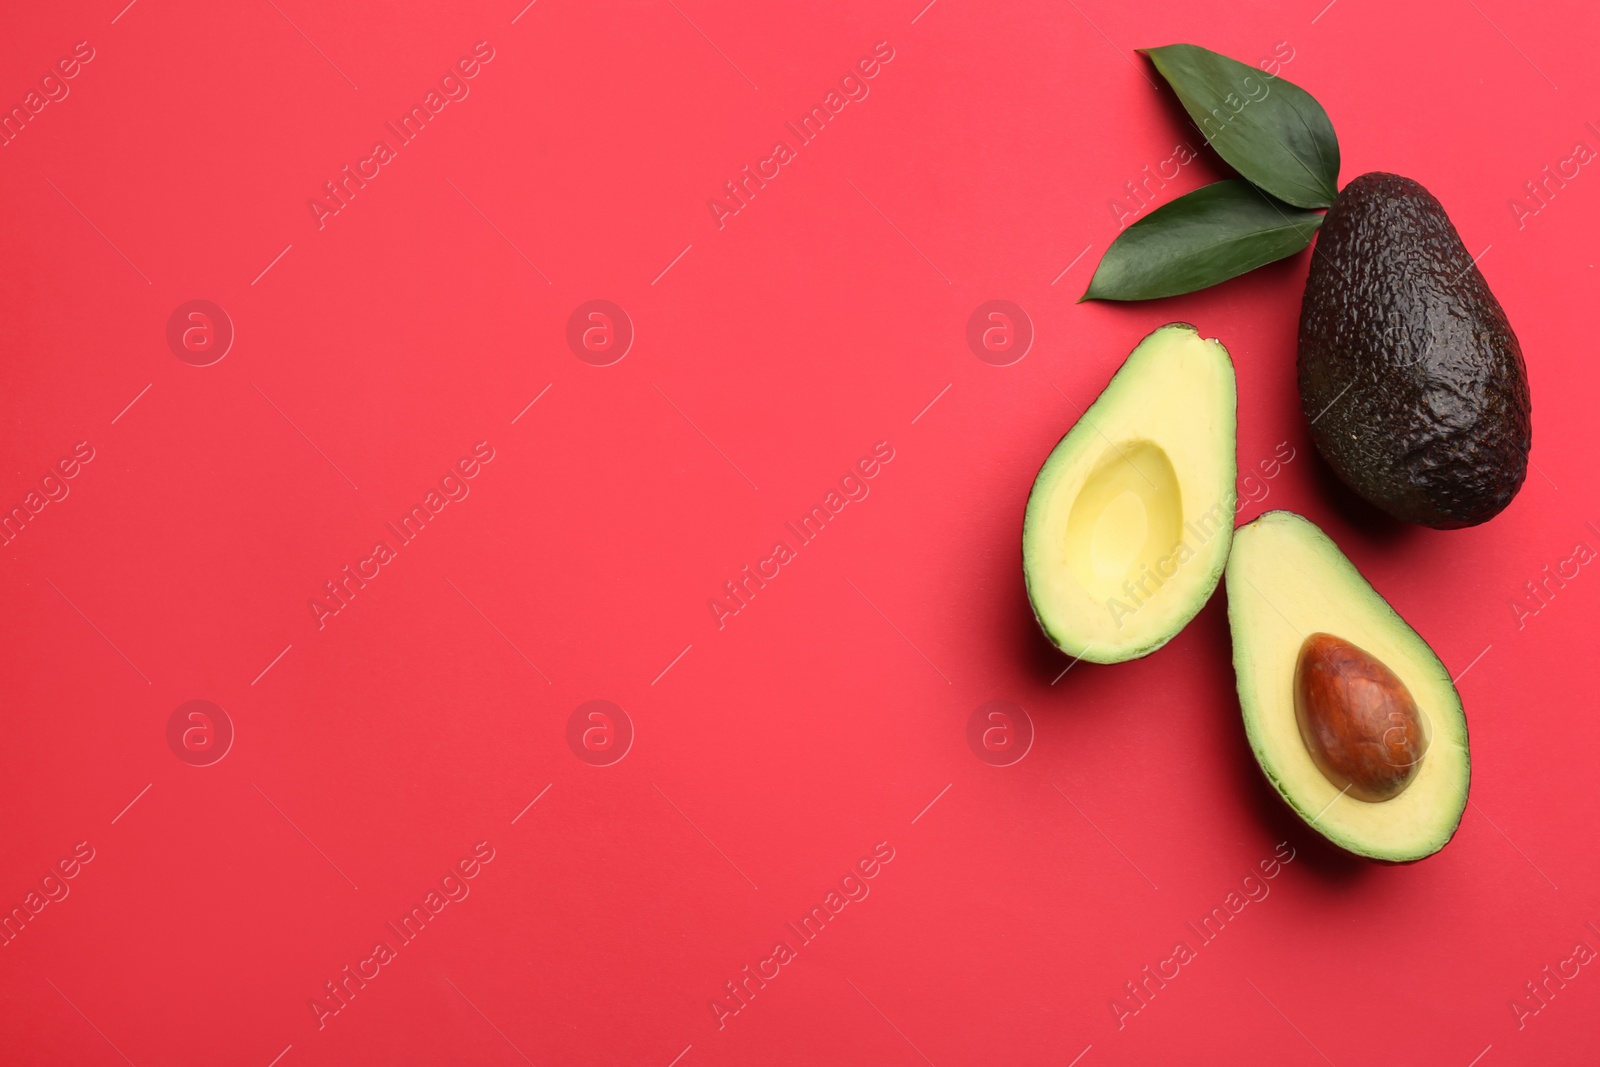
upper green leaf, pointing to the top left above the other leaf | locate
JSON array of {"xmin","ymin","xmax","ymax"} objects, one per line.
[{"xmin": 1144, "ymin": 45, "xmax": 1339, "ymax": 208}]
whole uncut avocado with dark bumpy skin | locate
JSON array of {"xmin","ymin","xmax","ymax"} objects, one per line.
[{"xmin": 1299, "ymin": 171, "xmax": 1531, "ymax": 530}]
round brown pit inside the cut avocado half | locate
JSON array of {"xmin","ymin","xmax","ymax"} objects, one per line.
[{"xmin": 1294, "ymin": 633, "xmax": 1427, "ymax": 803}]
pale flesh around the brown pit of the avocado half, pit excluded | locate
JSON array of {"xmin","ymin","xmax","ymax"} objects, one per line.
[{"xmin": 1227, "ymin": 512, "xmax": 1472, "ymax": 862}]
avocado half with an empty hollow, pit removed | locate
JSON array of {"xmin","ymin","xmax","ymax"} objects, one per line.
[{"xmin": 1022, "ymin": 323, "xmax": 1237, "ymax": 664}]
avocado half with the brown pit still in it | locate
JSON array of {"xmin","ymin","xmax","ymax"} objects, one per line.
[{"xmin": 1227, "ymin": 512, "xmax": 1472, "ymax": 862}]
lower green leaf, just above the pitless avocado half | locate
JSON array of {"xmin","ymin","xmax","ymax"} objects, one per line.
[{"xmin": 1078, "ymin": 178, "xmax": 1322, "ymax": 302}]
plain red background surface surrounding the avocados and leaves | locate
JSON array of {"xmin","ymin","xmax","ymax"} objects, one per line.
[{"xmin": 0, "ymin": 0, "xmax": 1600, "ymax": 1067}]
